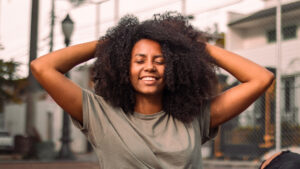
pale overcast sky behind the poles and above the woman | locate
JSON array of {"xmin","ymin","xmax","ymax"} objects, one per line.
[{"xmin": 0, "ymin": 0, "xmax": 263, "ymax": 76}]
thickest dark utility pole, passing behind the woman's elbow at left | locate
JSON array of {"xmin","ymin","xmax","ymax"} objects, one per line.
[{"xmin": 26, "ymin": 0, "xmax": 39, "ymax": 136}]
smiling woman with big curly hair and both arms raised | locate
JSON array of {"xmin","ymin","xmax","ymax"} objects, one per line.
[{"xmin": 31, "ymin": 13, "xmax": 274, "ymax": 168}]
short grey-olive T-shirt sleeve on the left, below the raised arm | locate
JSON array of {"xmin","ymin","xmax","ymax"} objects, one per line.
[{"xmin": 71, "ymin": 89, "xmax": 106, "ymax": 144}]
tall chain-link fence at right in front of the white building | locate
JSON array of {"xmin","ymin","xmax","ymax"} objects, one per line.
[{"xmin": 207, "ymin": 1, "xmax": 300, "ymax": 160}]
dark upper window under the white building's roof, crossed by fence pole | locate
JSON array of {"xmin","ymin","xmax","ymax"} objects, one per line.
[{"xmin": 267, "ymin": 25, "xmax": 297, "ymax": 43}]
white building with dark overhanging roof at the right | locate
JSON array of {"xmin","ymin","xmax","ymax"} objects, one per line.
[{"xmin": 225, "ymin": 0, "xmax": 300, "ymax": 124}]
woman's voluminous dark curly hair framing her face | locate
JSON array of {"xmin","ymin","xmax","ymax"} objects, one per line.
[{"xmin": 93, "ymin": 12, "xmax": 217, "ymax": 123}]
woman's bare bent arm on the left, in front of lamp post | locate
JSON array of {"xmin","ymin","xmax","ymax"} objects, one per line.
[{"xmin": 30, "ymin": 41, "xmax": 99, "ymax": 122}]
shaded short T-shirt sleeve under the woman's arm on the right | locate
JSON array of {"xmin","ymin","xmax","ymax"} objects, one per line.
[{"xmin": 199, "ymin": 103, "xmax": 219, "ymax": 144}]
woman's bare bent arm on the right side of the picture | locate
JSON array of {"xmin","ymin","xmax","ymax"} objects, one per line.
[{"xmin": 206, "ymin": 44, "xmax": 274, "ymax": 127}]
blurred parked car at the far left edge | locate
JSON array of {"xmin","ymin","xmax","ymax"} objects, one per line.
[{"xmin": 0, "ymin": 130, "xmax": 14, "ymax": 154}]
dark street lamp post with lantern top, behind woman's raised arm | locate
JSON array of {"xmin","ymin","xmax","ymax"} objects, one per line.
[{"xmin": 58, "ymin": 14, "xmax": 75, "ymax": 160}]
